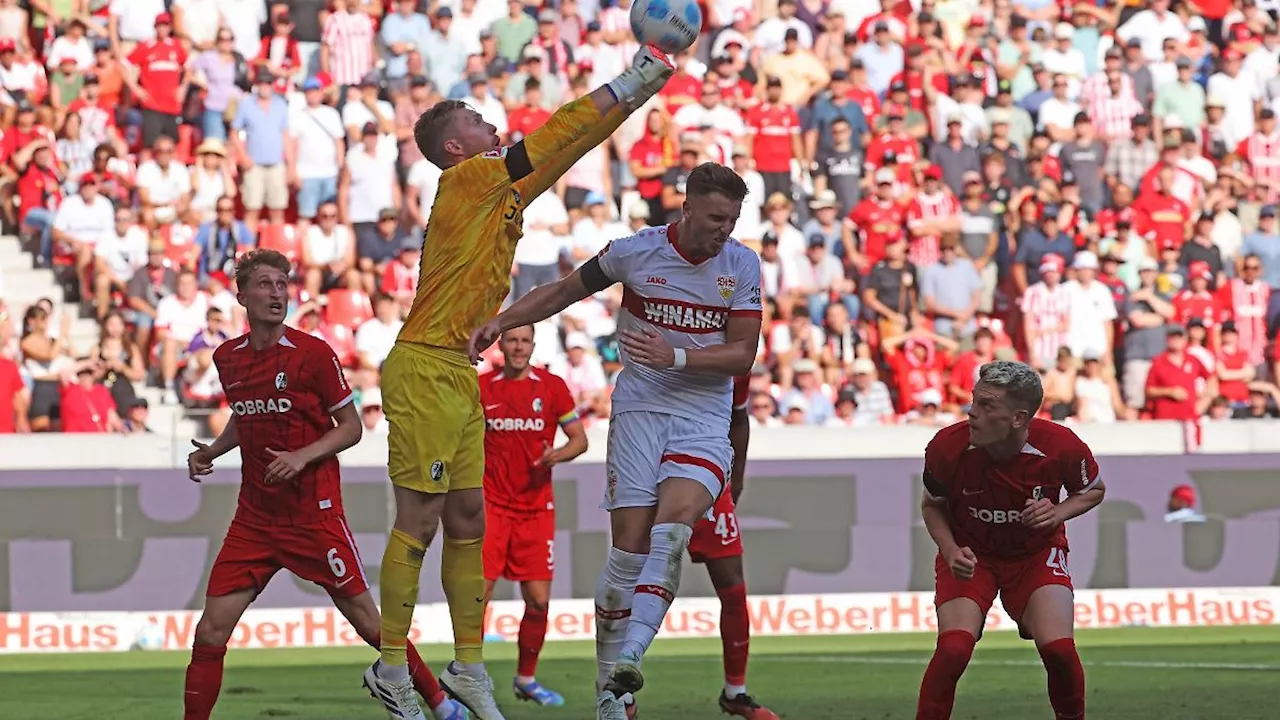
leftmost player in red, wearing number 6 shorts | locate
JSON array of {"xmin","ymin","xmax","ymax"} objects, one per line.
[{"xmin": 183, "ymin": 250, "xmax": 466, "ymax": 720}]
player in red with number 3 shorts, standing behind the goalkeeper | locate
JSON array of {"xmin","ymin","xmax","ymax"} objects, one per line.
[{"xmin": 480, "ymin": 325, "xmax": 586, "ymax": 707}]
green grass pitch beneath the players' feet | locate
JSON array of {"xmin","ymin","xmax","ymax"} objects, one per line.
[{"xmin": 0, "ymin": 626, "xmax": 1280, "ymax": 720}]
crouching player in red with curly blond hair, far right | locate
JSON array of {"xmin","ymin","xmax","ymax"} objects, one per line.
[{"xmin": 915, "ymin": 360, "xmax": 1106, "ymax": 720}]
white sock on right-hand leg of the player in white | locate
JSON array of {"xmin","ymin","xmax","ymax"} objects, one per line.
[{"xmin": 620, "ymin": 523, "xmax": 694, "ymax": 662}]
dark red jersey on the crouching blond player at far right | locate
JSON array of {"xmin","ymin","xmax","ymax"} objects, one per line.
[{"xmin": 924, "ymin": 419, "xmax": 1098, "ymax": 561}]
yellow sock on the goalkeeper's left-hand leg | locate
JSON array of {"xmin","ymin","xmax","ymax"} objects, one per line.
[{"xmin": 379, "ymin": 529, "xmax": 426, "ymax": 680}]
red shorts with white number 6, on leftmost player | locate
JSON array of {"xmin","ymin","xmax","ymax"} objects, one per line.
[{"xmin": 205, "ymin": 515, "xmax": 369, "ymax": 597}]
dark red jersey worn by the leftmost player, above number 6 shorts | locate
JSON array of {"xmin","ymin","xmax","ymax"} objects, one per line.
[{"xmin": 214, "ymin": 328, "xmax": 355, "ymax": 525}]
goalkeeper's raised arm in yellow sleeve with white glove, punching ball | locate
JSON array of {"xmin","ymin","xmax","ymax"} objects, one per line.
[{"xmin": 507, "ymin": 46, "xmax": 675, "ymax": 206}]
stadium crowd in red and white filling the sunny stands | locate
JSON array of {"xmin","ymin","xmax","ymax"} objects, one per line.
[{"xmin": 0, "ymin": 0, "xmax": 1280, "ymax": 432}]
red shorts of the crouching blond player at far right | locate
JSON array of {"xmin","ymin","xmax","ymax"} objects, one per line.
[{"xmin": 933, "ymin": 547, "xmax": 1074, "ymax": 623}]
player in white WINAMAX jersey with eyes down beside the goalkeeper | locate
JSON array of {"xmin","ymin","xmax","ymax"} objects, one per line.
[{"xmin": 471, "ymin": 163, "xmax": 760, "ymax": 720}]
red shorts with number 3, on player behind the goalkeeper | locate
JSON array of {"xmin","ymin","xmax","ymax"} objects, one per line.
[{"xmin": 484, "ymin": 503, "xmax": 556, "ymax": 583}]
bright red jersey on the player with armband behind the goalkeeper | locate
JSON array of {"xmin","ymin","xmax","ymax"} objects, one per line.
[{"xmin": 480, "ymin": 368, "xmax": 577, "ymax": 512}]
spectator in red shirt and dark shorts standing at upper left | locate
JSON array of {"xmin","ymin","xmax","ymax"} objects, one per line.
[{"xmin": 124, "ymin": 13, "xmax": 187, "ymax": 147}]
